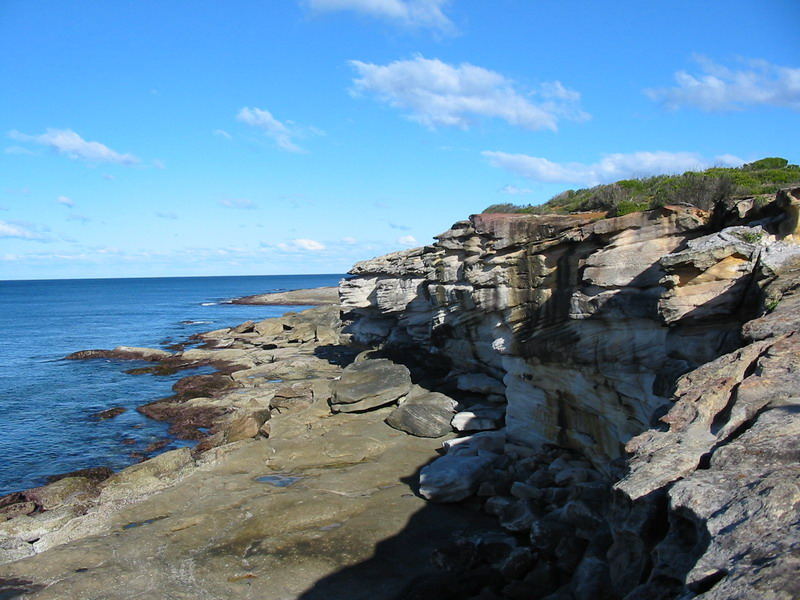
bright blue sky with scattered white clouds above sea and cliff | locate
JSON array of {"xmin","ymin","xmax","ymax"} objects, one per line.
[{"xmin": 0, "ymin": 0, "xmax": 800, "ymax": 279}]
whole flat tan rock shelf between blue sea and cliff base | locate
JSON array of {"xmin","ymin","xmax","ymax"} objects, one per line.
[{"xmin": 0, "ymin": 306, "xmax": 512, "ymax": 598}]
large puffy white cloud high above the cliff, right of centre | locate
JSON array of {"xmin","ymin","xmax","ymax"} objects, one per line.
[{"xmin": 350, "ymin": 56, "xmax": 589, "ymax": 131}]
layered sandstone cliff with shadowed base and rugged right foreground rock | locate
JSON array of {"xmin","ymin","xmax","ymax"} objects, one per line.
[{"xmin": 340, "ymin": 189, "xmax": 800, "ymax": 598}]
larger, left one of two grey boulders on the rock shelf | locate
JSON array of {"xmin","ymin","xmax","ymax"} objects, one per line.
[{"xmin": 330, "ymin": 358, "xmax": 411, "ymax": 412}]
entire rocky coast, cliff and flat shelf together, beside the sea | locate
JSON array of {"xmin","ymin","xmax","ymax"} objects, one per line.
[{"xmin": 0, "ymin": 189, "xmax": 800, "ymax": 600}]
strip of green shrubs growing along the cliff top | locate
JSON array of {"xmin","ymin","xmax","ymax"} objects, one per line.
[{"xmin": 483, "ymin": 158, "xmax": 800, "ymax": 216}]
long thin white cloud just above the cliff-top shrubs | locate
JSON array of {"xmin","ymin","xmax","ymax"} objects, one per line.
[{"xmin": 482, "ymin": 151, "xmax": 744, "ymax": 186}]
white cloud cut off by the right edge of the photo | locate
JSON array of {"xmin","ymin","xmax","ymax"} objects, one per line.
[{"xmin": 645, "ymin": 56, "xmax": 800, "ymax": 111}]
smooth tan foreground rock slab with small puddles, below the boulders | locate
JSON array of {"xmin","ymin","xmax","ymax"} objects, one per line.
[{"xmin": 0, "ymin": 382, "xmax": 491, "ymax": 600}]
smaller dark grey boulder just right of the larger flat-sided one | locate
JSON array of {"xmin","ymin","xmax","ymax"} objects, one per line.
[{"xmin": 386, "ymin": 388, "xmax": 457, "ymax": 437}]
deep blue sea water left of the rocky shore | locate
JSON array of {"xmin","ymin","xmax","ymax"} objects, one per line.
[{"xmin": 0, "ymin": 275, "xmax": 342, "ymax": 495}]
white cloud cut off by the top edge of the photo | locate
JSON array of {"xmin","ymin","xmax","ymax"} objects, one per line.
[{"xmin": 306, "ymin": 0, "xmax": 455, "ymax": 32}]
